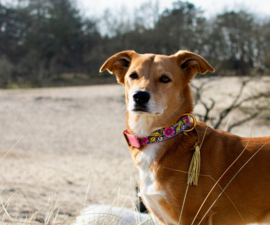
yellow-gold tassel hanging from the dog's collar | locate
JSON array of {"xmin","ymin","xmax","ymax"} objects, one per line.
[{"xmin": 187, "ymin": 145, "xmax": 201, "ymax": 185}]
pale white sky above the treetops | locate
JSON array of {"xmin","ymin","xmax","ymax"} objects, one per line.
[{"xmin": 77, "ymin": 0, "xmax": 270, "ymax": 17}]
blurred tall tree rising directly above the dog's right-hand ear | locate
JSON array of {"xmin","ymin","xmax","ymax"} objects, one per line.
[{"xmin": 155, "ymin": 1, "xmax": 206, "ymax": 54}]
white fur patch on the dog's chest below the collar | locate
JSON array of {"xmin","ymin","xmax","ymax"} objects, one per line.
[{"xmin": 137, "ymin": 143, "xmax": 177, "ymax": 224}]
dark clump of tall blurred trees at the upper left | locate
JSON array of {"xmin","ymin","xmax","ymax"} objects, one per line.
[{"xmin": 0, "ymin": 0, "xmax": 101, "ymax": 85}]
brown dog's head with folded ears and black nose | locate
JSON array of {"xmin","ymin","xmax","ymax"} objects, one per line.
[{"xmin": 100, "ymin": 51, "xmax": 214, "ymax": 135}]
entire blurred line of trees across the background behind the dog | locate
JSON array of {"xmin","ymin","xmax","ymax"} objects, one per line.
[{"xmin": 0, "ymin": 0, "xmax": 270, "ymax": 87}]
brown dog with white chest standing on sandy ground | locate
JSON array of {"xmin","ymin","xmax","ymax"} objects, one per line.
[{"xmin": 100, "ymin": 51, "xmax": 270, "ymax": 225}]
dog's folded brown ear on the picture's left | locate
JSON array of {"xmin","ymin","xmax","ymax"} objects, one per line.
[{"xmin": 99, "ymin": 50, "xmax": 136, "ymax": 84}]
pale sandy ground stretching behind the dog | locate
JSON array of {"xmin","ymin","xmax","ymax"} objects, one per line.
[{"xmin": 0, "ymin": 78, "xmax": 270, "ymax": 222}]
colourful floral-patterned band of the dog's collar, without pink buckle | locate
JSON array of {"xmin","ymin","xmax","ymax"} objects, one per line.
[{"xmin": 138, "ymin": 115, "xmax": 190, "ymax": 145}]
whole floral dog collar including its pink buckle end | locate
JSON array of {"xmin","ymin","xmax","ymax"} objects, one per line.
[{"xmin": 123, "ymin": 114, "xmax": 193, "ymax": 148}]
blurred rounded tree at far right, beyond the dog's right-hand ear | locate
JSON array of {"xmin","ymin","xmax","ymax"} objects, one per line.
[{"xmin": 208, "ymin": 11, "xmax": 261, "ymax": 75}]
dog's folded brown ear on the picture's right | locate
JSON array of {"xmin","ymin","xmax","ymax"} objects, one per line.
[{"xmin": 175, "ymin": 51, "xmax": 215, "ymax": 79}]
